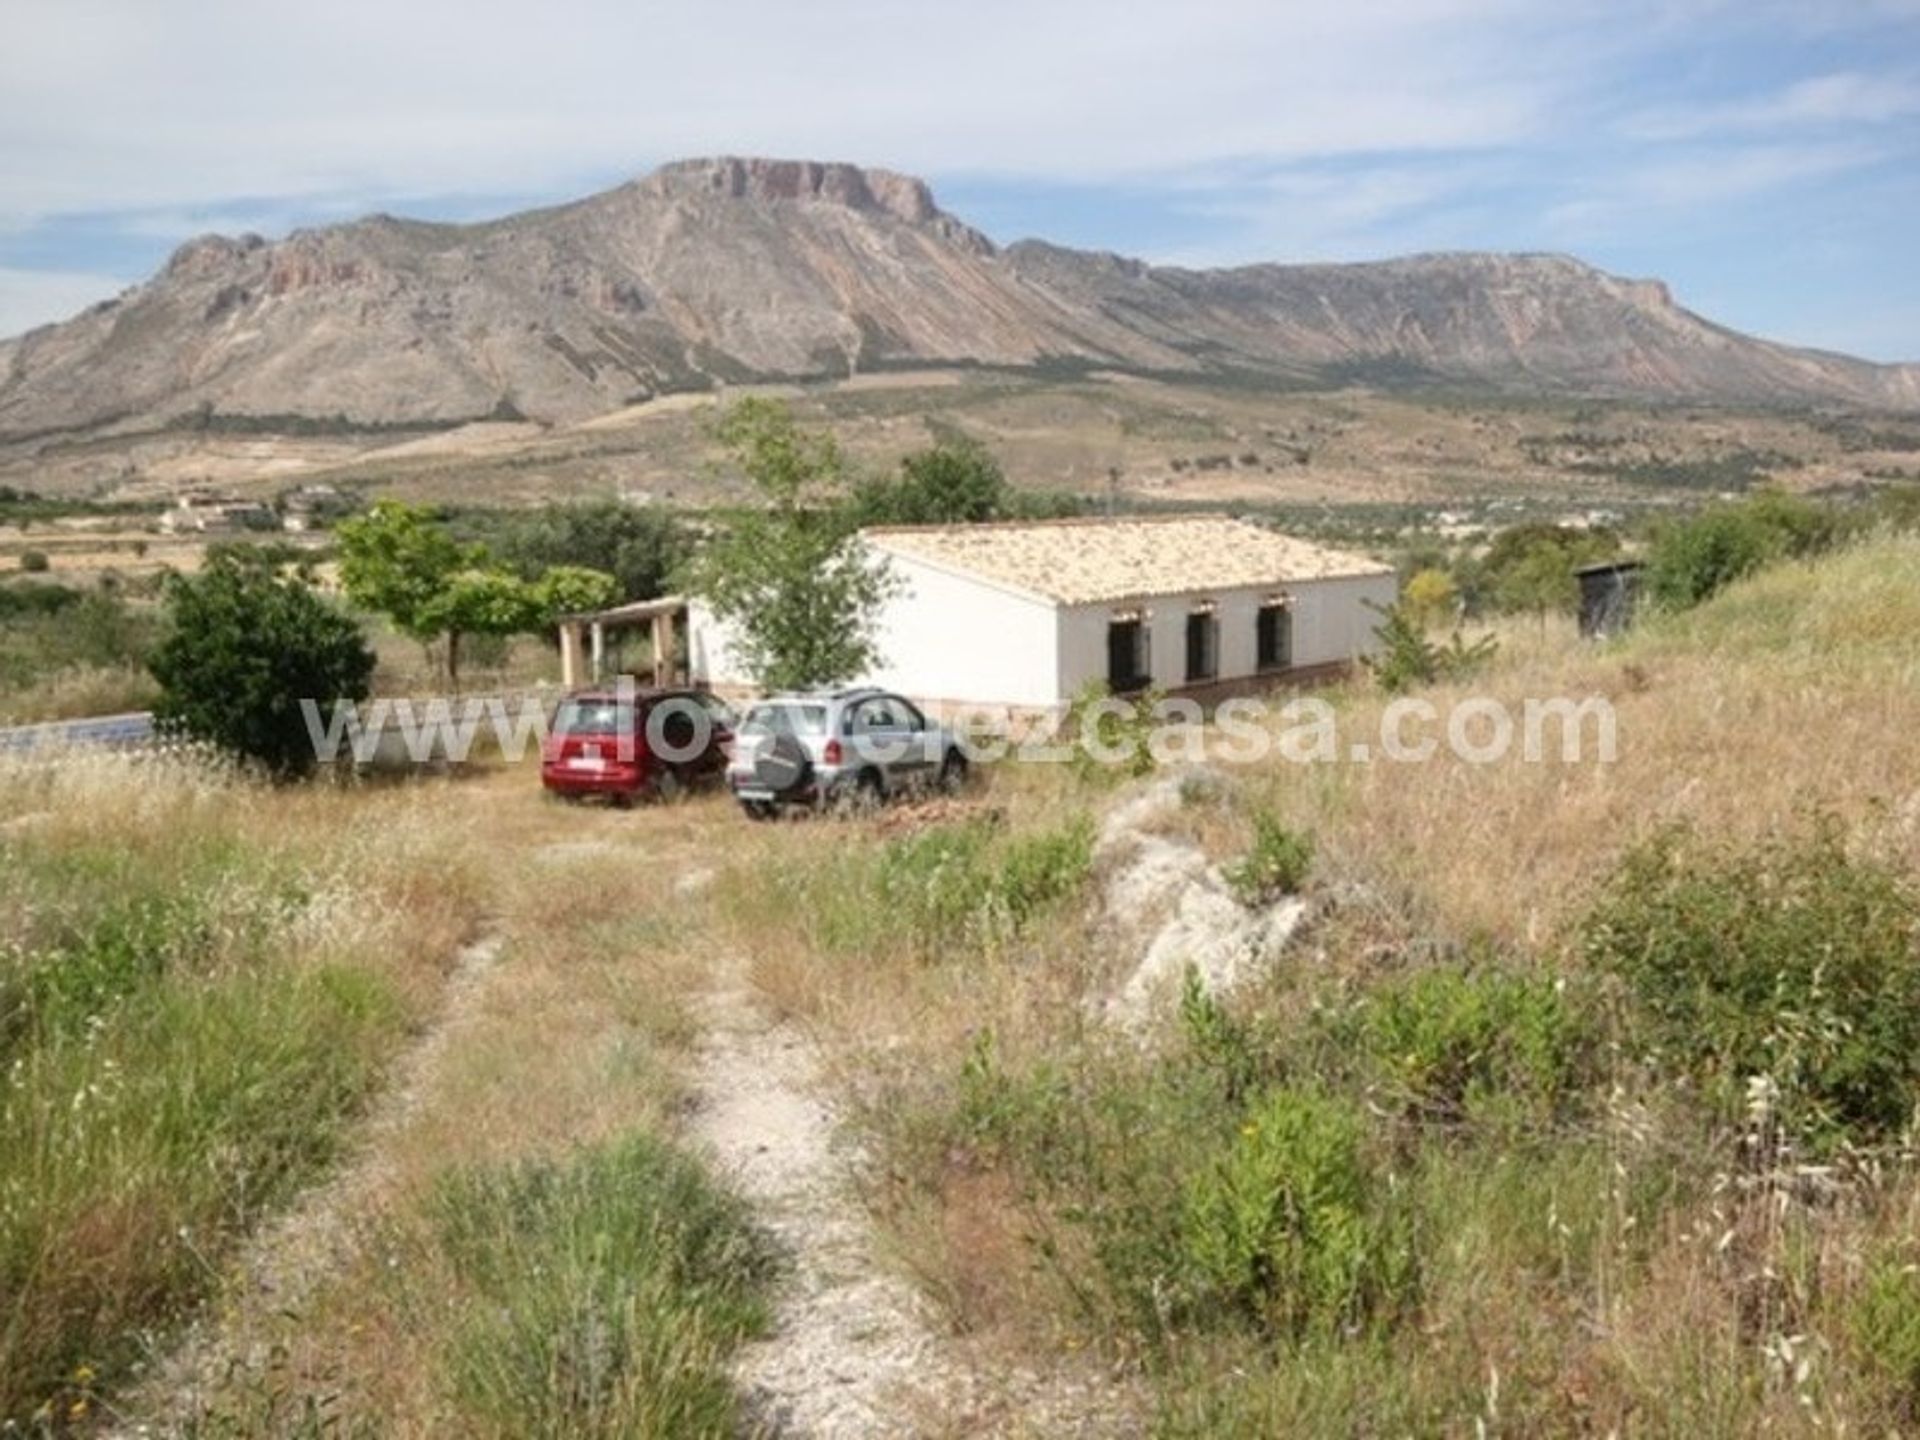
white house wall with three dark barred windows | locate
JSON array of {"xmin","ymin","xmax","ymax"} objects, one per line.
[{"xmin": 1060, "ymin": 574, "xmax": 1398, "ymax": 697}]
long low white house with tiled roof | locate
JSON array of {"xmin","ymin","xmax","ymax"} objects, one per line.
[{"xmin": 687, "ymin": 515, "xmax": 1396, "ymax": 710}]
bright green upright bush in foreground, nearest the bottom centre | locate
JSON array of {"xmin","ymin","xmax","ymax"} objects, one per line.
[{"xmin": 1183, "ymin": 1089, "xmax": 1413, "ymax": 1334}]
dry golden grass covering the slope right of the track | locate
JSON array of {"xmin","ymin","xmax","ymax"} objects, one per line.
[{"xmin": 687, "ymin": 540, "xmax": 1920, "ymax": 1436}]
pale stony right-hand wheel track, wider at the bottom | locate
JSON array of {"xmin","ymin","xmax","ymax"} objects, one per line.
[{"xmin": 691, "ymin": 973, "xmax": 1131, "ymax": 1440}]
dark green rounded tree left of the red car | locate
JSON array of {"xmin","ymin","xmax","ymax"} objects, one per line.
[{"xmin": 148, "ymin": 551, "xmax": 374, "ymax": 780}]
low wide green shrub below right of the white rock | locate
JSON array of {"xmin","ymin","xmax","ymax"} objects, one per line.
[{"xmin": 1332, "ymin": 966, "xmax": 1601, "ymax": 1123}]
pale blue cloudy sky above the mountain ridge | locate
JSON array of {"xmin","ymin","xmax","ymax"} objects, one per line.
[{"xmin": 0, "ymin": 0, "xmax": 1920, "ymax": 361}]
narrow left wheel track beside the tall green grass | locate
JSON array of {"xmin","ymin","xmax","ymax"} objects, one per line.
[{"xmin": 109, "ymin": 933, "xmax": 501, "ymax": 1440}]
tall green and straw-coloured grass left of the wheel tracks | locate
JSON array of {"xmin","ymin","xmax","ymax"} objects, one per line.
[{"xmin": 0, "ymin": 755, "xmax": 487, "ymax": 1421}]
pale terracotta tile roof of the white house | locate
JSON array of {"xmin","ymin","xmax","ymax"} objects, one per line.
[{"xmin": 860, "ymin": 515, "xmax": 1392, "ymax": 605}]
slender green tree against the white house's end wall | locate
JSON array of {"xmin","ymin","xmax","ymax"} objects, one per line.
[{"xmin": 687, "ymin": 397, "xmax": 893, "ymax": 689}]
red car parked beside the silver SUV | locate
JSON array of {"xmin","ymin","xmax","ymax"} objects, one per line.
[{"xmin": 540, "ymin": 689, "xmax": 733, "ymax": 804}]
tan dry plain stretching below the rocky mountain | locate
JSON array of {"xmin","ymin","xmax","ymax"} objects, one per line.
[{"xmin": 0, "ymin": 378, "xmax": 1920, "ymax": 518}]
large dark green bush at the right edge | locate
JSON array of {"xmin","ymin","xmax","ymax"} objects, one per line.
[{"xmin": 1582, "ymin": 822, "xmax": 1920, "ymax": 1148}]
